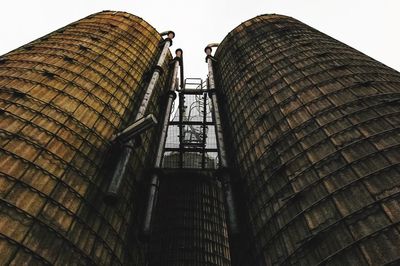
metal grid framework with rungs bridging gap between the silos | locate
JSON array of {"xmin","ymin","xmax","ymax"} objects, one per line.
[{"xmin": 163, "ymin": 78, "xmax": 218, "ymax": 169}]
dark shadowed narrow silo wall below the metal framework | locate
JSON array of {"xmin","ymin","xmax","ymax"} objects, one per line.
[{"xmin": 150, "ymin": 171, "xmax": 231, "ymax": 266}]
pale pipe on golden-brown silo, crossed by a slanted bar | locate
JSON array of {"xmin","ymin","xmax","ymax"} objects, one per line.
[{"xmin": 106, "ymin": 31, "xmax": 175, "ymax": 202}]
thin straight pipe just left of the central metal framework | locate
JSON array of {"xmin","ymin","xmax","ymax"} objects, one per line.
[{"xmin": 143, "ymin": 49, "xmax": 182, "ymax": 237}]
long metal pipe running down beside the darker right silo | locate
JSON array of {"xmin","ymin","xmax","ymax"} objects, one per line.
[{"xmin": 204, "ymin": 43, "xmax": 239, "ymax": 236}]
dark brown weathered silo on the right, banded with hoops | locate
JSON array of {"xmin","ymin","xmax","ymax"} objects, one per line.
[{"xmin": 215, "ymin": 15, "xmax": 400, "ymax": 265}]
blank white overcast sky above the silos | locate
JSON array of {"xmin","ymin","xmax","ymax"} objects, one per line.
[{"xmin": 0, "ymin": 0, "xmax": 400, "ymax": 78}]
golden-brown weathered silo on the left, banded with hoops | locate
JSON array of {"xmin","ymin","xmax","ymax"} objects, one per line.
[{"xmin": 0, "ymin": 11, "xmax": 170, "ymax": 265}]
